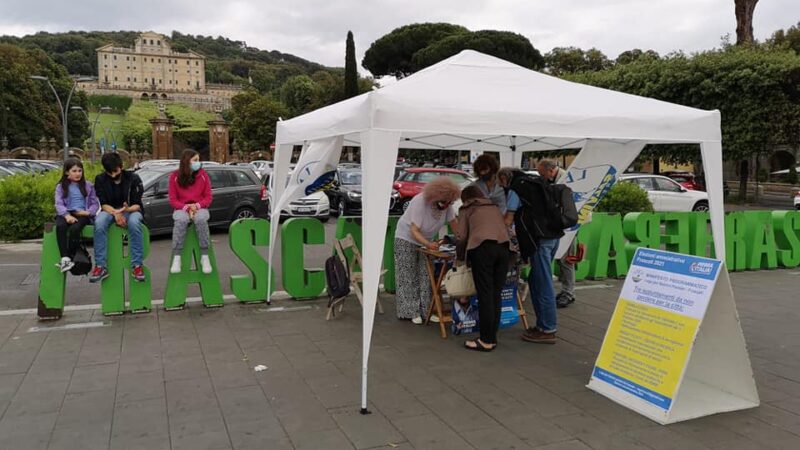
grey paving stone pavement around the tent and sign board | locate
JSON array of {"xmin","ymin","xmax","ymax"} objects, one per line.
[{"xmin": 0, "ymin": 270, "xmax": 800, "ymax": 450}]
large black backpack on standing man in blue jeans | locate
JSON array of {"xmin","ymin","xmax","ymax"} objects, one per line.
[{"xmin": 511, "ymin": 174, "xmax": 578, "ymax": 256}]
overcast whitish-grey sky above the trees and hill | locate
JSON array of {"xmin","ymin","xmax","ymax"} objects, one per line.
[{"xmin": 0, "ymin": 0, "xmax": 800, "ymax": 72}]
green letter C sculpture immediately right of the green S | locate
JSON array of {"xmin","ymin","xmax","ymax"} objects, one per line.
[{"xmin": 281, "ymin": 218, "xmax": 325, "ymax": 298}]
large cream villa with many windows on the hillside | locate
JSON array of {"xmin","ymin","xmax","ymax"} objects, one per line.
[{"xmin": 79, "ymin": 32, "xmax": 241, "ymax": 111}]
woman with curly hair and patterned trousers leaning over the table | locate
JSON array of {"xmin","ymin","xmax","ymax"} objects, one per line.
[{"xmin": 394, "ymin": 177, "xmax": 461, "ymax": 325}]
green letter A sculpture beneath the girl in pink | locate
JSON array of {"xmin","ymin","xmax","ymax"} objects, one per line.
[{"xmin": 164, "ymin": 225, "xmax": 223, "ymax": 310}]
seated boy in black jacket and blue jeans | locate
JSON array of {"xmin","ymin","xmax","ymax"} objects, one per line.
[{"xmin": 89, "ymin": 153, "xmax": 145, "ymax": 283}]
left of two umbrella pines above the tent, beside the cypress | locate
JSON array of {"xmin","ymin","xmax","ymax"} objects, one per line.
[{"xmin": 361, "ymin": 23, "xmax": 468, "ymax": 78}]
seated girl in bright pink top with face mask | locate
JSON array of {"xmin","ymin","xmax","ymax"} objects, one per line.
[{"xmin": 169, "ymin": 149, "xmax": 212, "ymax": 274}]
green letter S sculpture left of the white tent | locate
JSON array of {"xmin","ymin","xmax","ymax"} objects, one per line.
[{"xmin": 228, "ymin": 219, "xmax": 275, "ymax": 303}]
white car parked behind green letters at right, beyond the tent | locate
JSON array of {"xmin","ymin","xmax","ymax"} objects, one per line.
[{"xmin": 619, "ymin": 174, "xmax": 708, "ymax": 211}]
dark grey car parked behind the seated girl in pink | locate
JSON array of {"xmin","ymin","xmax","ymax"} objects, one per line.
[{"xmin": 136, "ymin": 162, "xmax": 267, "ymax": 235}]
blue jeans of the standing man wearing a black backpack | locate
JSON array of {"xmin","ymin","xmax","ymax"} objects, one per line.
[{"xmin": 528, "ymin": 239, "xmax": 558, "ymax": 333}]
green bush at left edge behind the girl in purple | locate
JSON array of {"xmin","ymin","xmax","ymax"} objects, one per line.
[{"xmin": 0, "ymin": 164, "xmax": 102, "ymax": 241}]
